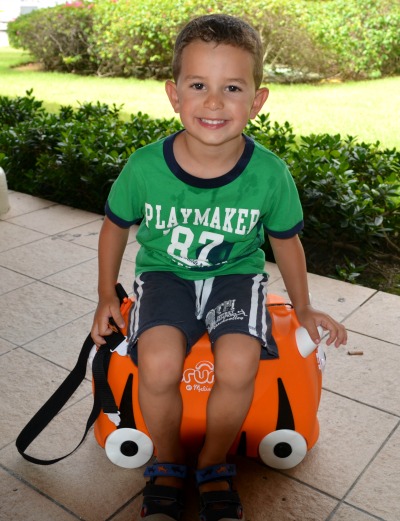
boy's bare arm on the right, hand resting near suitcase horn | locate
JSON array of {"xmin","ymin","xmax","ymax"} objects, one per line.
[{"xmin": 269, "ymin": 235, "xmax": 347, "ymax": 347}]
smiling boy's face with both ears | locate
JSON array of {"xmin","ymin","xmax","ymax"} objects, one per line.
[{"xmin": 166, "ymin": 40, "xmax": 268, "ymax": 145}]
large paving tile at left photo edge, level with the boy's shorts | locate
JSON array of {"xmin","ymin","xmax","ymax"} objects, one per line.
[{"xmin": 0, "ymin": 282, "xmax": 96, "ymax": 345}]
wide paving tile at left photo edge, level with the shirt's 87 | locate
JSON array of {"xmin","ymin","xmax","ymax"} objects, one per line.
[{"xmin": 0, "ymin": 237, "xmax": 96, "ymax": 279}]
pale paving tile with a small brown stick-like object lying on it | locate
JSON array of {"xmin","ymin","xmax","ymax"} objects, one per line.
[{"xmin": 323, "ymin": 331, "xmax": 400, "ymax": 416}]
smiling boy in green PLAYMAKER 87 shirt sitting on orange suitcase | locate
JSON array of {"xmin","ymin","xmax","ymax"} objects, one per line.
[{"xmin": 92, "ymin": 15, "xmax": 346, "ymax": 521}]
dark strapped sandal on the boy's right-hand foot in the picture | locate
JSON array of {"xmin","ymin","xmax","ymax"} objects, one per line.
[{"xmin": 196, "ymin": 463, "xmax": 244, "ymax": 521}]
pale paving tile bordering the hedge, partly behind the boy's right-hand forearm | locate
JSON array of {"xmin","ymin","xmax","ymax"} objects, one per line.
[{"xmin": 270, "ymin": 273, "xmax": 376, "ymax": 325}]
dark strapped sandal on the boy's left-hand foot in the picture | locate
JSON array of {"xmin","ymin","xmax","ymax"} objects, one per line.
[{"xmin": 140, "ymin": 463, "xmax": 187, "ymax": 521}]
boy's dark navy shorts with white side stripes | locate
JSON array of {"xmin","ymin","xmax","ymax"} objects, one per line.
[{"xmin": 129, "ymin": 271, "xmax": 278, "ymax": 363}]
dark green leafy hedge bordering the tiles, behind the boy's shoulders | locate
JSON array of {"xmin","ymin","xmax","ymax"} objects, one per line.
[{"xmin": 0, "ymin": 92, "xmax": 400, "ymax": 272}]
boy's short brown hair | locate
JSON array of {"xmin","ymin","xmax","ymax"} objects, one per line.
[{"xmin": 172, "ymin": 14, "xmax": 263, "ymax": 89}]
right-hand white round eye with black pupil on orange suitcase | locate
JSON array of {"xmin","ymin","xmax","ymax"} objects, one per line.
[{"xmin": 258, "ymin": 429, "xmax": 307, "ymax": 469}]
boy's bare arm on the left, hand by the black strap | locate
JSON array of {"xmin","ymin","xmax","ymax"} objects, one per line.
[{"xmin": 91, "ymin": 217, "xmax": 129, "ymax": 345}]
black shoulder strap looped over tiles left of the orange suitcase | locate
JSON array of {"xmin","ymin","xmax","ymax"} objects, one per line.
[{"xmin": 15, "ymin": 285, "xmax": 126, "ymax": 465}]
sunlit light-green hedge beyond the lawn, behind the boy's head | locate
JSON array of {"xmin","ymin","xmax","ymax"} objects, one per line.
[{"xmin": 8, "ymin": 0, "xmax": 400, "ymax": 81}]
